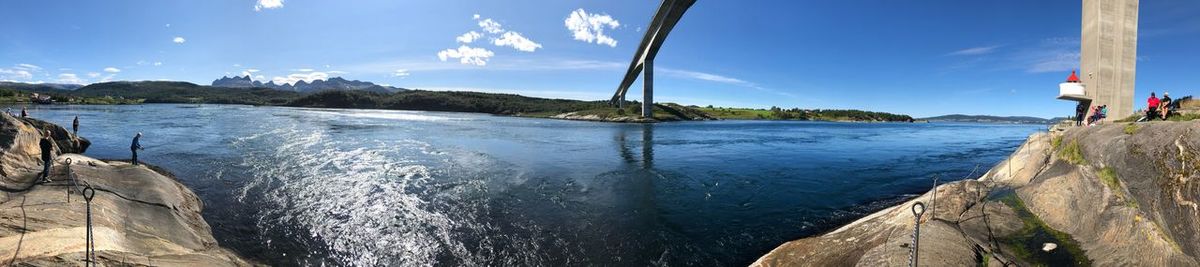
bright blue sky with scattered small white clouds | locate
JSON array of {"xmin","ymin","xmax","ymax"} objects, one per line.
[{"xmin": 0, "ymin": 0, "xmax": 1200, "ymax": 117}]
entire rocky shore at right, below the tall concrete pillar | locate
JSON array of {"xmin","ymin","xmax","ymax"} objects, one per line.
[{"xmin": 752, "ymin": 121, "xmax": 1200, "ymax": 266}]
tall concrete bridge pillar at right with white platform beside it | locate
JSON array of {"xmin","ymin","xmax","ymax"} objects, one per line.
[{"xmin": 1058, "ymin": 0, "xmax": 1138, "ymax": 119}]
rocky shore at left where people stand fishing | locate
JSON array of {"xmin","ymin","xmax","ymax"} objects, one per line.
[{"xmin": 0, "ymin": 114, "xmax": 257, "ymax": 266}]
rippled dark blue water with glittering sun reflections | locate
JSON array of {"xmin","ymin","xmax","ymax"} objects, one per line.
[{"xmin": 7, "ymin": 105, "xmax": 1044, "ymax": 266}]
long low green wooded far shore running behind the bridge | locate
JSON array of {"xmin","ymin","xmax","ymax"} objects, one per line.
[{"xmin": 7, "ymin": 81, "xmax": 912, "ymax": 121}]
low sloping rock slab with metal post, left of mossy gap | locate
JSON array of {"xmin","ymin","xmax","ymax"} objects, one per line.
[{"xmin": 752, "ymin": 180, "xmax": 1021, "ymax": 266}]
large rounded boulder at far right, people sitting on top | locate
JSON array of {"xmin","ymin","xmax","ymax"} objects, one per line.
[{"xmin": 1018, "ymin": 121, "xmax": 1200, "ymax": 266}]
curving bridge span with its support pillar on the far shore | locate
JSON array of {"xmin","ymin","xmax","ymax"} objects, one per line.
[{"xmin": 610, "ymin": 0, "xmax": 696, "ymax": 118}]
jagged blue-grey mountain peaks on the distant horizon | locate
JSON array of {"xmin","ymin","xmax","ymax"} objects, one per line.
[{"xmin": 212, "ymin": 76, "xmax": 407, "ymax": 93}]
